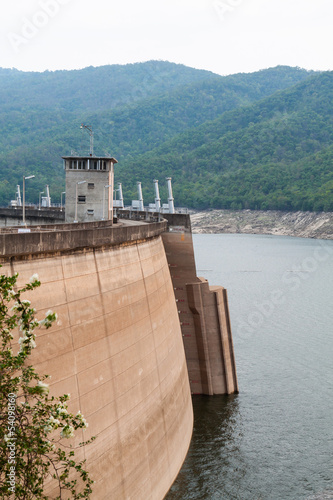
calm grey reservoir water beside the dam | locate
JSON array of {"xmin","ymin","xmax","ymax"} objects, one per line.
[{"xmin": 167, "ymin": 234, "xmax": 333, "ymax": 500}]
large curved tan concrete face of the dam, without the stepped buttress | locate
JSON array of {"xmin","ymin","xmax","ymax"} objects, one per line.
[{"xmin": 2, "ymin": 224, "xmax": 193, "ymax": 500}]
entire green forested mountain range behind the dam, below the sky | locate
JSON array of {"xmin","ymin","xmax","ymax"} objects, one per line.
[{"xmin": 0, "ymin": 61, "xmax": 333, "ymax": 210}]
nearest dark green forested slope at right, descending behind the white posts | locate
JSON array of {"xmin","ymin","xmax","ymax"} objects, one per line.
[{"xmin": 120, "ymin": 72, "xmax": 333, "ymax": 211}]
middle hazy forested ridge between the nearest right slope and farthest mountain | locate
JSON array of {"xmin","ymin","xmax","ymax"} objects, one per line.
[{"xmin": 88, "ymin": 67, "xmax": 309, "ymax": 160}]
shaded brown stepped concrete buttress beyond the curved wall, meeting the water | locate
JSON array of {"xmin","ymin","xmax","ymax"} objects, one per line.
[{"xmin": 162, "ymin": 214, "xmax": 238, "ymax": 395}]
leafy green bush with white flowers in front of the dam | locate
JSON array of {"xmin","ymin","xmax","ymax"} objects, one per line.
[{"xmin": 0, "ymin": 274, "xmax": 94, "ymax": 500}]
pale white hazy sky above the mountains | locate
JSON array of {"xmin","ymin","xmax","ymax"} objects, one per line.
[{"xmin": 0, "ymin": 0, "xmax": 333, "ymax": 75}]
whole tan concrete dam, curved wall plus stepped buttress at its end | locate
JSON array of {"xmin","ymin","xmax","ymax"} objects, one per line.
[{"xmin": 0, "ymin": 214, "xmax": 238, "ymax": 500}]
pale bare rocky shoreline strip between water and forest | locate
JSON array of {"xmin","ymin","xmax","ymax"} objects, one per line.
[{"xmin": 191, "ymin": 210, "xmax": 333, "ymax": 240}]
